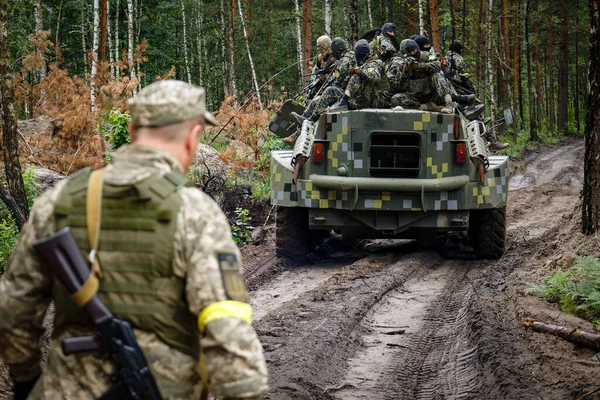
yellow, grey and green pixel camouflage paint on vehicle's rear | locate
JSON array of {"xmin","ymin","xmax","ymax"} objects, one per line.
[{"xmin": 271, "ymin": 109, "xmax": 509, "ymax": 234}]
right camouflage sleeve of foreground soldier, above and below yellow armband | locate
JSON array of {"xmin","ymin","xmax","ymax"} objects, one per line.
[{"xmin": 175, "ymin": 188, "xmax": 267, "ymax": 398}]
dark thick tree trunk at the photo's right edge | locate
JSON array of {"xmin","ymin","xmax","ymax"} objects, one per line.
[{"xmin": 581, "ymin": 0, "xmax": 600, "ymax": 235}]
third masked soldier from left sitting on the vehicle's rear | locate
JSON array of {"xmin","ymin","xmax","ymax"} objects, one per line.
[{"xmin": 329, "ymin": 39, "xmax": 384, "ymax": 111}]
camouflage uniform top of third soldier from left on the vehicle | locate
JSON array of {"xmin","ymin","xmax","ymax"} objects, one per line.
[{"xmin": 346, "ymin": 57, "xmax": 384, "ymax": 110}]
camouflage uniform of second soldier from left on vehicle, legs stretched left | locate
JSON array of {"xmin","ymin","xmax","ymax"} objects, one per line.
[{"xmin": 302, "ymin": 50, "xmax": 356, "ymax": 117}]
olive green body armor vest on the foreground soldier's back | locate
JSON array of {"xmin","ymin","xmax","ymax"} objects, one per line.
[{"xmin": 53, "ymin": 168, "xmax": 198, "ymax": 358}]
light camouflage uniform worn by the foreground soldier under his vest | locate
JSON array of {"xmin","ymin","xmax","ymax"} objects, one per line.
[{"xmin": 0, "ymin": 81, "xmax": 267, "ymax": 400}]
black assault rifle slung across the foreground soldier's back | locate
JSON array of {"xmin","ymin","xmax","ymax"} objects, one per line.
[{"xmin": 34, "ymin": 228, "xmax": 162, "ymax": 400}]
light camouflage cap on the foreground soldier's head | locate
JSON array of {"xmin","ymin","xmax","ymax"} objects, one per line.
[{"xmin": 127, "ymin": 79, "xmax": 219, "ymax": 127}]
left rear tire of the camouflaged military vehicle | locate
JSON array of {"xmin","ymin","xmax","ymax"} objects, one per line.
[{"xmin": 275, "ymin": 207, "xmax": 325, "ymax": 260}]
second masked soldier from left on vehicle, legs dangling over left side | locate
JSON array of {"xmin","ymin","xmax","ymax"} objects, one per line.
[{"xmin": 290, "ymin": 37, "xmax": 356, "ymax": 146}]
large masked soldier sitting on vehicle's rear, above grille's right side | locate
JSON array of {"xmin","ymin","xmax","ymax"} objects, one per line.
[{"xmin": 392, "ymin": 39, "xmax": 454, "ymax": 114}]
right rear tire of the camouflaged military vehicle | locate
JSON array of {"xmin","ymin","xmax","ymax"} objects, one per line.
[{"xmin": 469, "ymin": 208, "xmax": 506, "ymax": 259}]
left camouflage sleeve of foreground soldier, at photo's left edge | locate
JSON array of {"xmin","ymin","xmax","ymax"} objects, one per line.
[{"xmin": 0, "ymin": 182, "xmax": 65, "ymax": 381}]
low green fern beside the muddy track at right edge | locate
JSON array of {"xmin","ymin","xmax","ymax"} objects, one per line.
[{"xmin": 525, "ymin": 256, "xmax": 600, "ymax": 328}]
